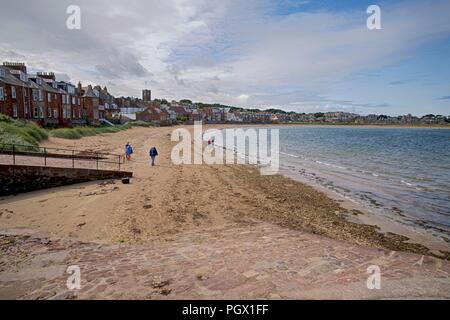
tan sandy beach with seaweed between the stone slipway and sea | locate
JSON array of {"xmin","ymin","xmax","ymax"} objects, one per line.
[{"xmin": 0, "ymin": 125, "xmax": 450, "ymax": 260}]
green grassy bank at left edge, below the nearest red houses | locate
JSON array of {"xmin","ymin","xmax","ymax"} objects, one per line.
[{"xmin": 0, "ymin": 115, "xmax": 48, "ymax": 150}]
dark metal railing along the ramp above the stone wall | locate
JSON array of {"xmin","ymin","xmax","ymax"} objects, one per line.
[{"xmin": 0, "ymin": 143, "xmax": 124, "ymax": 171}]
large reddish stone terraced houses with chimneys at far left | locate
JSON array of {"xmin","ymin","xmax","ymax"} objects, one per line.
[{"xmin": 0, "ymin": 62, "xmax": 120, "ymax": 127}]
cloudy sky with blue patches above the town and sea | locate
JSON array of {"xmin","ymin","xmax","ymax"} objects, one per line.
[{"xmin": 0, "ymin": 0, "xmax": 450, "ymax": 115}]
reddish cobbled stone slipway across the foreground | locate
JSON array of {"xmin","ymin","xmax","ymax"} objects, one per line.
[{"xmin": 0, "ymin": 222, "xmax": 450, "ymax": 299}]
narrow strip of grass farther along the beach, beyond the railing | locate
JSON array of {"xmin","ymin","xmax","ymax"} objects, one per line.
[{"xmin": 49, "ymin": 121, "xmax": 152, "ymax": 139}]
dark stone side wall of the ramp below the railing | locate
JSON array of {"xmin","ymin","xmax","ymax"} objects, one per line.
[{"xmin": 0, "ymin": 165, "xmax": 133, "ymax": 196}]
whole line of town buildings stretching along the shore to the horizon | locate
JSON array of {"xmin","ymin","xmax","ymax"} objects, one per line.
[{"xmin": 0, "ymin": 62, "xmax": 450, "ymax": 127}]
